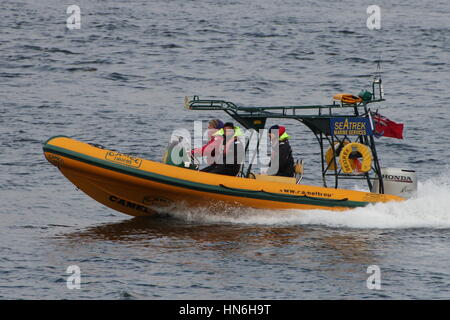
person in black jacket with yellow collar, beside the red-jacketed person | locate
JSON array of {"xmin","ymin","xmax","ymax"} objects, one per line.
[{"xmin": 201, "ymin": 122, "xmax": 244, "ymax": 176}]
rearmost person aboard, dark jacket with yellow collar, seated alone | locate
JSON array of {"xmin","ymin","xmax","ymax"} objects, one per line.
[{"xmin": 268, "ymin": 125, "xmax": 295, "ymax": 177}]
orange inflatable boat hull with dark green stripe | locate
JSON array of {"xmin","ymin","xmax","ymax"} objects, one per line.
[{"xmin": 43, "ymin": 136, "xmax": 404, "ymax": 216}]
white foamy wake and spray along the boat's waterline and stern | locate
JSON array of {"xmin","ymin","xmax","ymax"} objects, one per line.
[{"xmin": 172, "ymin": 170, "xmax": 450, "ymax": 229}]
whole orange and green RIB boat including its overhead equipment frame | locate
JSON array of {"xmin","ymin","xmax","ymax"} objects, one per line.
[{"xmin": 43, "ymin": 78, "xmax": 416, "ymax": 216}]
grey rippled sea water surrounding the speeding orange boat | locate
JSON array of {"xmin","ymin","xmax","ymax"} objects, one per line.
[{"xmin": 0, "ymin": 0, "xmax": 450, "ymax": 299}]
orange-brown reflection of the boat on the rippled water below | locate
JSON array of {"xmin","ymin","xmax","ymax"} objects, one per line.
[{"xmin": 58, "ymin": 215, "xmax": 384, "ymax": 271}]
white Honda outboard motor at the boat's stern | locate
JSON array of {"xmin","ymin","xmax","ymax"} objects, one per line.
[{"xmin": 372, "ymin": 168, "xmax": 417, "ymax": 198}]
